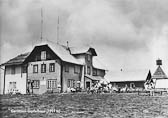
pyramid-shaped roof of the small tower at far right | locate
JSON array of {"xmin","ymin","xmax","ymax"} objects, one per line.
[{"xmin": 152, "ymin": 66, "xmax": 167, "ymax": 79}]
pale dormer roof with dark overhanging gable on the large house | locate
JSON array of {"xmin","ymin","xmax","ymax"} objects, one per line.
[{"xmin": 70, "ymin": 46, "xmax": 97, "ymax": 56}]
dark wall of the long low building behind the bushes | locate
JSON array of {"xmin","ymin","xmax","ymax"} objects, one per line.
[{"xmin": 110, "ymin": 81, "xmax": 145, "ymax": 88}]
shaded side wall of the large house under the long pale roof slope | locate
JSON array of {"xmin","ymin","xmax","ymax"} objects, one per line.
[{"xmin": 62, "ymin": 63, "xmax": 82, "ymax": 92}]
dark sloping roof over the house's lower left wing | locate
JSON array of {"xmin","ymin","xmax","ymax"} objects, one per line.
[{"xmin": 2, "ymin": 52, "xmax": 30, "ymax": 66}]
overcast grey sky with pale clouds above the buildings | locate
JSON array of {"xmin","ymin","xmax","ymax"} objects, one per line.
[{"xmin": 0, "ymin": 0, "xmax": 168, "ymax": 79}]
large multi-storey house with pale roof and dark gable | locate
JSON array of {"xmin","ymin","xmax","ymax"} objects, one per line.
[{"xmin": 1, "ymin": 42, "xmax": 106, "ymax": 94}]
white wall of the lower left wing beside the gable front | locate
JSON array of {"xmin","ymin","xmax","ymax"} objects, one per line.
[{"xmin": 5, "ymin": 66, "xmax": 26, "ymax": 94}]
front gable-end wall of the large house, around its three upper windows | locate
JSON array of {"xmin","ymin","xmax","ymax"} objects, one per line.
[{"xmin": 28, "ymin": 59, "xmax": 61, "ymax": 94}]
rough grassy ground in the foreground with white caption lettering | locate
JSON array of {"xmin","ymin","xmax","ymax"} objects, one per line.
[{"xmin": 0, "ymin": 93, "xmax": 168, "ymax": 118}]
